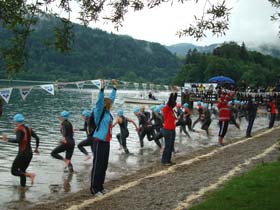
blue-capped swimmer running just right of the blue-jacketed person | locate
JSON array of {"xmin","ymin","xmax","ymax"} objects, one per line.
[{"xmin": 113, "ymin": 109, "xmax": 138, "ymax": 154}]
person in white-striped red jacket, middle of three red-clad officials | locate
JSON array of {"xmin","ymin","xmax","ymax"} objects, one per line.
[{"xmin": 217, "ymin": 95, "xmax": 230, "ymax": 146}]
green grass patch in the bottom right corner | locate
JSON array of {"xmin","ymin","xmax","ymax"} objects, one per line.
[{"xmin": 190, "ymin": 161, "xmax": 280, "ymax": 210}]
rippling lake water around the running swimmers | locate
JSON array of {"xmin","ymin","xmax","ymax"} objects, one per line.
[{"xmin": 0, "ymin": 89, "xmax": 274, "ymax": 209}]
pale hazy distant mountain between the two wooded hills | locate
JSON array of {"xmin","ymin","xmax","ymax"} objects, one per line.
[{"xmin": 165, "ymin": 43, "xmax": 220, "ymax": 56}]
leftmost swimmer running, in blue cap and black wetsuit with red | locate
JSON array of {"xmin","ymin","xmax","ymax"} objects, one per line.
[{"xmin": 2, "ymin": 114, "xmax": 40, "ymax": 189}]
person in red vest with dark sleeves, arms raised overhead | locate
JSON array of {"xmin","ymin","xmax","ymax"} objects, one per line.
[{"xmin": 161, "ymin": 87, "xmax": 177, "ymax": 165}]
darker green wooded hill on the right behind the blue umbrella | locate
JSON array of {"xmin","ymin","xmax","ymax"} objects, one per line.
[{"xmin": 174, "ymin": 42, "xmax": 280, "ymax": 86}]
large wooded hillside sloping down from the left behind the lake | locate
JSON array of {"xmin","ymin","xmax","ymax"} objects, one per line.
[{"xmin": 0, "ymin": 15, "xmax": 183, "ymax": 83}]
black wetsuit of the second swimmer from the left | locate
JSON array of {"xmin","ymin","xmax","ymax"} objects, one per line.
[{"xmin": 51, "ymin": 120, "xmax": 75, "ymax": 171}]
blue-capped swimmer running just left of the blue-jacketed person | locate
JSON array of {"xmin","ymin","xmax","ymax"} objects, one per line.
[{"xmin": 75, "ymin": 110, "xmax": 95, "ymax": 161}]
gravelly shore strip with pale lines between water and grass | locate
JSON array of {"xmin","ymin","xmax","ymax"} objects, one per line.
[{"xmin": 24, "ymin": 127, "xmax": 280, "ymax": 210}]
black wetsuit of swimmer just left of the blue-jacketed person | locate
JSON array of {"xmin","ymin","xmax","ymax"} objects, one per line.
[{"xmin": 78, "ymin": 116, "xmax": 95, "ymax": 155}]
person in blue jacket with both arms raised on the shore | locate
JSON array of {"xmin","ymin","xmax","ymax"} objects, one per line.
[{"xmin": 90, "ymin": 80, "xmax": 117, "ymax": 196}]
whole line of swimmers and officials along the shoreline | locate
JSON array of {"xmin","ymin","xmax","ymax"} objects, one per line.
[{"xmin": 2, "ymin": 80, "xmax": 276, "ymax": 196}]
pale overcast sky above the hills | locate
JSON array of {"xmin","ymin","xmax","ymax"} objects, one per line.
[{"xmin": 84, "ymin": 0, "xmax": 279, "ymax": 45}]
